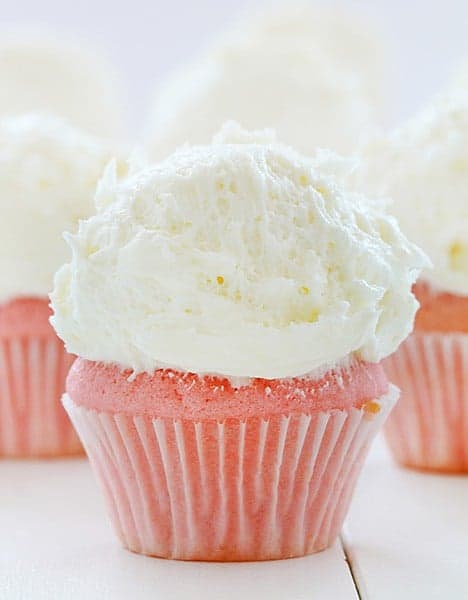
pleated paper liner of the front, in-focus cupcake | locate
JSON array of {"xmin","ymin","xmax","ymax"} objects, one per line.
[{"xmin": 63, "ymin": 387, "xmax": 398, "ymax": 561}]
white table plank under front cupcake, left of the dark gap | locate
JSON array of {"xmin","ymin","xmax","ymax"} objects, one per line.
[{"xmin": 0, "ymin": 460, "xmax": 357, "ymax": 600}]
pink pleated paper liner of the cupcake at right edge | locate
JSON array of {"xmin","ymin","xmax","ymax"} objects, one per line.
[{"xmin": 384, "ymin": 332, "xmax": 468, "ymax": 472}]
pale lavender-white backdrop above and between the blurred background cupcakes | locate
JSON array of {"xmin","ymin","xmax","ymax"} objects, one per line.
[{"xmin": 0, "ymin": 0, "xmax": 468, "ymax": 136}]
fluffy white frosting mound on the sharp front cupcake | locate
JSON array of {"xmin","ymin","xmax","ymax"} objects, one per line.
[{"xmin": 51, "ymin": 124, "xmax": 426, "ymax": 379}]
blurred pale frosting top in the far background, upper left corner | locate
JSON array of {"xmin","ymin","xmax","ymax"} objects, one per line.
[{"xmin": 0, "ymin": 29, "xmax": 125, "ymax": 140}]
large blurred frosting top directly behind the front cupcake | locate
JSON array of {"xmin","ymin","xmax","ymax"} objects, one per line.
[{"xmin": 148, "ymin": 3, "xmax": 385, "ymax": 159}]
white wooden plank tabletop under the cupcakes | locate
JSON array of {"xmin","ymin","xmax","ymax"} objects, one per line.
[{"xmin": 0, "ymin": 441, "xmax": 468, "ymax": 600}]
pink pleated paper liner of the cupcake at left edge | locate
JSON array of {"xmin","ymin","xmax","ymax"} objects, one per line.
[{"xmin": 0, "ymin": 336, "xmax": 82, "ymax": 457}]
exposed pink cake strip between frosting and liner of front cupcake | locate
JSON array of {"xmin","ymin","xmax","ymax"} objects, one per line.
[{"xmin": 67, "ymin": 358, "xmax": 388, "ymax": 420}]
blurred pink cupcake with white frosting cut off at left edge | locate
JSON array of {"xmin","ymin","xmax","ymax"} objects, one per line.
[{"xmin": 0, "ymin": 115, "xmax": 124, "ymax": 457}]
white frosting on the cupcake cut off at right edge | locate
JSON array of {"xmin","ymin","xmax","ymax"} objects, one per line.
[{"xmin": 356, "ymin": 86, "xmax": 468, "ymax": 296}]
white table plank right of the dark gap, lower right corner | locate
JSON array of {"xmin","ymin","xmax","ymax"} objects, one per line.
[{"xmin": 343, "ymin": 440, "xmax": 468, "ymax": 600}]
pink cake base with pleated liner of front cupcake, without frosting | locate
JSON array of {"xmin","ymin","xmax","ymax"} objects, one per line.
[{"xmin": 64, "ymin": 358, "xmax": 395, "ymax": 561}]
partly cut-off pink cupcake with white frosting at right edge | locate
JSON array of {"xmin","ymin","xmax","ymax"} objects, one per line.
[{"xmin": 354, "ymin": 89, "xmax": 468, "ymax": 472}]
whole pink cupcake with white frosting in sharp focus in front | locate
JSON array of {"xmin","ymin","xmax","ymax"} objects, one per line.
[{"xmin": 51, "ymin": 124, "xmax": 425, "ymax": 561}]
